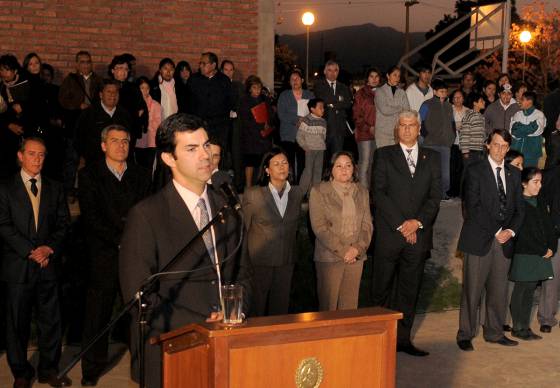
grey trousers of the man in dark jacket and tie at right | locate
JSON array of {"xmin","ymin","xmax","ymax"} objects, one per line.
[{"xmin": 457, "ymin": 239, "xmax": 510, "ymax": 341}]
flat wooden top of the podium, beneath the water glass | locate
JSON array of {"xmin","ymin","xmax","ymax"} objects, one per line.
[{"xmin": 150, "ymin": 307, "xmax": 402, "ymax": 344}]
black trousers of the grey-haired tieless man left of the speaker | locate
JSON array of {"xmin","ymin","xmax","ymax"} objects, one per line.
[{"xmin": 82, "ymin": 286, "xmax": 118, "ymax": 378}]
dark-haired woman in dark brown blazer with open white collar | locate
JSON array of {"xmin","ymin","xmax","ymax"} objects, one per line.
[{"xmin": 242, "ymin": 147, "xmax": 303, "ymax": 316}]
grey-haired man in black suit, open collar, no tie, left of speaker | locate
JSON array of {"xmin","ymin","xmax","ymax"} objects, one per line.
[{"xmin": 78, "ymin": 124, "xmax": 151, "ymax": 386}]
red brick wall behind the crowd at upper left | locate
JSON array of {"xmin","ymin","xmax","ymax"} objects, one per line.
[{"xmin": 0, "ymin": 0, "xmax": 258, "ymax": 80}]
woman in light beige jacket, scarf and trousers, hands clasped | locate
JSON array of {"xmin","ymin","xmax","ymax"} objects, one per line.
[{"xmin": 309, "ymin": 151, "xmax": 373, "ymax": 311}]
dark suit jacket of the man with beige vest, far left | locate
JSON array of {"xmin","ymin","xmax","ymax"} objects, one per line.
[{"xmin": 0, "ymin": 172, "xmax": 70, "ymax": 283}]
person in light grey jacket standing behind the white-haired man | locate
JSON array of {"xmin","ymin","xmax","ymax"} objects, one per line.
[{"xmin": 375, "ymin": 66, "xmax": 410, "ymax": 148}]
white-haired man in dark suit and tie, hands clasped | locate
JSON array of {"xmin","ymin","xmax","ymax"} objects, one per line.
[{"xmin": 372, "ymin": 111, "xmax": 442, "ymax": 356}]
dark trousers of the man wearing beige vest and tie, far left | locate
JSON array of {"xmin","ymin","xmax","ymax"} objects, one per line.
[{"xmin": 4, "ymin": 274, "xmax": 62, "ymax": 379}]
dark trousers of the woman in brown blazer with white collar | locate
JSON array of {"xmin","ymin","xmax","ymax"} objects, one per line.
[{"xmin": 253, "ymin": 264, "xmax": 294, "ymax": 316}]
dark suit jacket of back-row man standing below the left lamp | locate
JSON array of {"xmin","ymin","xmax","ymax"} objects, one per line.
[{"xmin": 313, "ymin": 78, "xmax": 352, "ymax": 138}]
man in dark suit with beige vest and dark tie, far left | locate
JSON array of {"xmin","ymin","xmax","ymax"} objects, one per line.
[{"xmin": 0, "ymin": 138, "xmax": 72, "ymax": 388}]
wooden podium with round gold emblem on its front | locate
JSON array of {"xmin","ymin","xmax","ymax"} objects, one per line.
[{"xmin": 151, "ymin": 307, "xmax": 402, "ymax": 388}]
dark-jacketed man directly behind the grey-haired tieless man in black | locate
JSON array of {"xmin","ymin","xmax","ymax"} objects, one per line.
[{"xmin": 76, "ymin": 79, "xmax": 132, "ymax": 165}]
